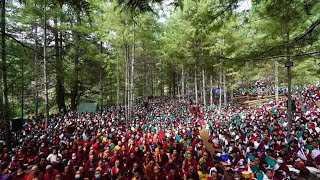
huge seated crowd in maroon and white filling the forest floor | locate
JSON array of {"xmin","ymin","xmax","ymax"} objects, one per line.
[{"xmin": 0, "ymin": 83, "xmax": 320, "ymax": 180}]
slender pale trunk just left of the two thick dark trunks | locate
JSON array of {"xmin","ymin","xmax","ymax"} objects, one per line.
[{"xmin": 43, "ymin": 0, "xmax": 49, "ymax": 128}]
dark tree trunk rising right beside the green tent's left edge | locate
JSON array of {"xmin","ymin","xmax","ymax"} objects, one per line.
[{"xmin": 71, "ymin": 14, "xmax": 81, "ymax": 110}]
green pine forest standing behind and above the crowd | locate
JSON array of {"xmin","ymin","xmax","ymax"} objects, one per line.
[{"xmin": 0, "ymin": 0, "xmax": 320, "ymax": 129}]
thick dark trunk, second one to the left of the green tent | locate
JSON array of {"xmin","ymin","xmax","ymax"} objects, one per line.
[{"xmin": 54, "ymin": 18, "xmax": 66, "ymax": 112}]
